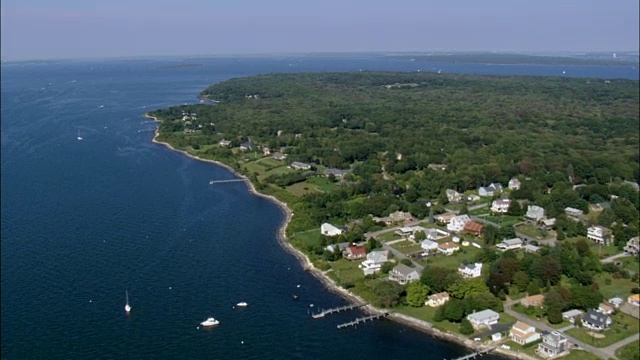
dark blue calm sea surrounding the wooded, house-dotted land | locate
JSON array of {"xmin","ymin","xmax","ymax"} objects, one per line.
[{"xmin": 1, "ymin": 56, "xmax": 638, "ymax": 359}]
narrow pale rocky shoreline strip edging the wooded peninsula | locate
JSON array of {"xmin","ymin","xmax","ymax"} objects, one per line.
[{"xmin": 144, "ymin": 113, "xmax": 537, "ymax": 360}]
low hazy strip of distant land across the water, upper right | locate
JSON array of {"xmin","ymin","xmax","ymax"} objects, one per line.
[{"xmin": 388, "ymin": 53, "xmax": 638, "ymax": 66}]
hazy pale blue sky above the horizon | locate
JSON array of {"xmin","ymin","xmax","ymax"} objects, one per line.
[{"xmin": 1, "ymin": 0, "xmax": 639, "ymax": 60}]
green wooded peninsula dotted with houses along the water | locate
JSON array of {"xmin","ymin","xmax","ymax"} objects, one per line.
[{"xmin": 147, "ymin": 71, "xmax": 640, "ymax": 359}]
